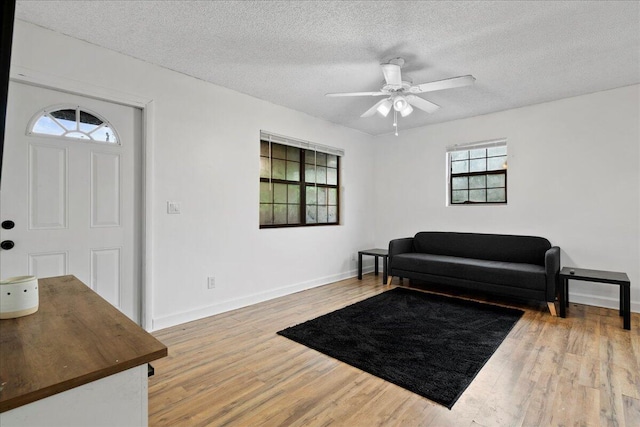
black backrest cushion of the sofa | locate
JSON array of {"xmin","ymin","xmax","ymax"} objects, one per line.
[{"xmin": 416, "ymin": 231, "xmax": 551, "ymax": 267}]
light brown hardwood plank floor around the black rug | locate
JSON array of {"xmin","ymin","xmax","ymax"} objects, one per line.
[{"xmin": 149, "ymin": 274, "xmax": 640, "ymax": 427}]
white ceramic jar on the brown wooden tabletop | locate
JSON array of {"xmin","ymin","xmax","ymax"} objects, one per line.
[{"xmin": 0, "ymin": 276, "xmax": 40, "ymax": 319}]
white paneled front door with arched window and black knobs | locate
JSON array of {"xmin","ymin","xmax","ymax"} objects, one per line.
[{"xmin": 0, "ymin": 82, "xmax": 142, "ymax": 323}]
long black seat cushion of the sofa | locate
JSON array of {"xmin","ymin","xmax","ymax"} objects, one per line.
[{"xmin": 393, "ymin": 252, "xmax": 546, "ymax": 290}]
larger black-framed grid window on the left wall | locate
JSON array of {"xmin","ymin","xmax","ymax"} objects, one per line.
[{"xmin": 260, "ymin": 132, "xmax": 344, "ymax": 228}]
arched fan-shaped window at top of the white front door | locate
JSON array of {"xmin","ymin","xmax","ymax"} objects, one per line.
[{"xmin": 27, "ymin": 106, "xmax": 119, "ymax": 144}]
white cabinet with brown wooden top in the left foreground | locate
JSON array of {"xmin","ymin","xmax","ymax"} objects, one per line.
[{"xmin": 0, "ymin": 276, "xmax": 167, "ymax": 426}]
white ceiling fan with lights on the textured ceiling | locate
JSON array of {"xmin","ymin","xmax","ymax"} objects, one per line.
[{"xmin": 326, "ymin": 58, "xmax": 476, "ymax": 135}]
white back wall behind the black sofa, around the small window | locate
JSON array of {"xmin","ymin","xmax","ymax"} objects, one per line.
[{"xmin": 375, "ymin": 85, "xmax": 640, "ymax": 311}]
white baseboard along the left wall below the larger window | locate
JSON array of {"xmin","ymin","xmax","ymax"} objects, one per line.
[{"xmin": 150, "ymin": 265, "xmax": 382, "ymax": 332}]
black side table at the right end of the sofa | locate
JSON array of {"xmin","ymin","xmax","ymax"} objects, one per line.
[{"xmin": 558, "ymin": 267, "xmax": 631, "ymax": 330}]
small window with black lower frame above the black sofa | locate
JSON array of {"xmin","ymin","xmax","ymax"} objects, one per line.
[{"xmin": 447, "ymin": 140, "xmax": 507, "ymax": 205}]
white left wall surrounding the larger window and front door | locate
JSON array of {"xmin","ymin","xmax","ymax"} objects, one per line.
[{"xmin": 12, "ymin": 21, "xmax": 374, "ymax": 329}]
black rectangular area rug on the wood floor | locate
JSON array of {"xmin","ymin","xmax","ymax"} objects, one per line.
[{"xmin": 278, "ymin": 288, "xmax": 524, "ymax": 409}]
